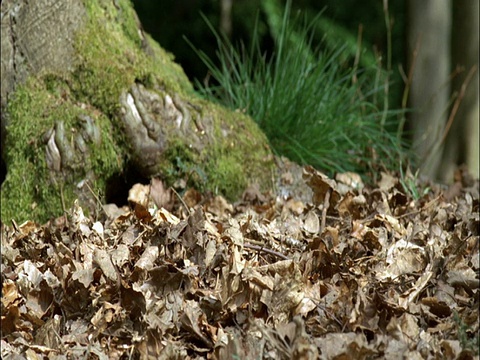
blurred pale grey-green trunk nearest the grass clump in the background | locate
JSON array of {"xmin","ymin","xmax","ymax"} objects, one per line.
[{"xmin": 408, "ymin": 0, "xmax": 451, "ymax": 178}]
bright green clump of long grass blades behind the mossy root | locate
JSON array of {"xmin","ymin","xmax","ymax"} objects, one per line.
[{"xmin": 188, "ymin": 3, "xmax": 402, "ymax": 173}]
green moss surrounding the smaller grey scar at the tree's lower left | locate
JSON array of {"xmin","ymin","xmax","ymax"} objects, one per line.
[{"xmin": 1, "ymin": 75, "xmax": 127, "ymax": 221}]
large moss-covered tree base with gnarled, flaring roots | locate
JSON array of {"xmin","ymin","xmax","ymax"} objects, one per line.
[{"xmin": 1, "ymin": 0, "xmax": 273, "ymax": 221}]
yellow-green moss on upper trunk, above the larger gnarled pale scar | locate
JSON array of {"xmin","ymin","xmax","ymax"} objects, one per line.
[{"xmin": 71, "ymin": 0, "xmax": 193, "ymax": 115}]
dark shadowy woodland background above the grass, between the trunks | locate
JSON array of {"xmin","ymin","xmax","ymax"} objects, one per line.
[{"xmin": 133, "ymin": 0, "xmax": 406, "ymax": 107}]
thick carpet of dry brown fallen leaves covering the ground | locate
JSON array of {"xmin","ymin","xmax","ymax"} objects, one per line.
[{"xmin": 1, "ymin": 162, "xmax": 480, "ymax": 359}]
